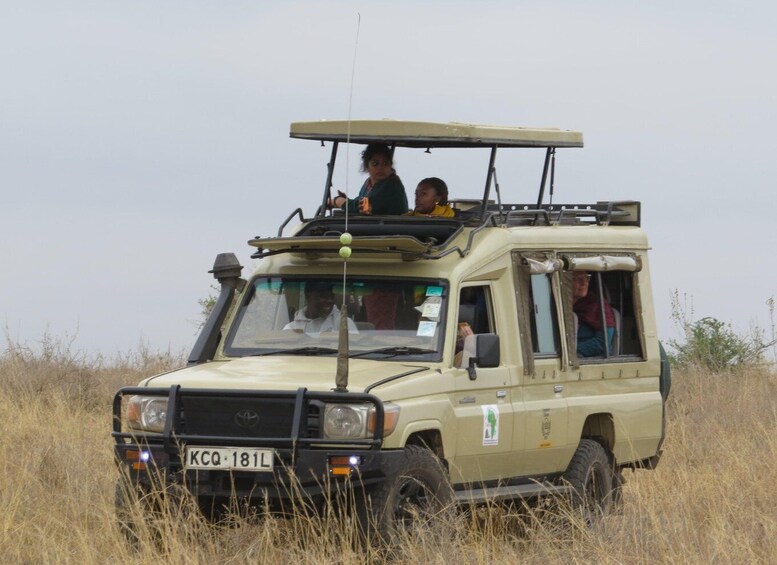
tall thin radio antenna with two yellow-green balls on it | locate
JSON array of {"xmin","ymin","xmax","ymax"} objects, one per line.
[{"xmin": 335, "ymin": 12, "xmax": 362, "ymax": 392}]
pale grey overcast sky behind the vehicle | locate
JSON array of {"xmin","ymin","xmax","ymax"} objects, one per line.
[{"xmin": 0, "ymin": 0, "xmax": 777, "ymax": 354}]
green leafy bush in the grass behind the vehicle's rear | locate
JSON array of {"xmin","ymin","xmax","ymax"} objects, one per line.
[{"xmin": 668, "ymin": 290, "xmax": 774, "ymax": 372}]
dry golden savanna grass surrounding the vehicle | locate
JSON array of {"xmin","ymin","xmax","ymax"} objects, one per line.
[{"xmin": 0, "ymin": 332, "xmax": 777, "ymax": 564}]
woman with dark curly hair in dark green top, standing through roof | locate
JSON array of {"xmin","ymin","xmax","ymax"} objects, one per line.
[{"xmin": 329, "ymin": 143, "xmax": 407, "ymax": 215}]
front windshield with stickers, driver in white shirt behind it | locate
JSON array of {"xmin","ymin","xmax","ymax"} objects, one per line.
[{"xmin": 224, "ymin": 276, "xmax": 448, "ymax": 361}]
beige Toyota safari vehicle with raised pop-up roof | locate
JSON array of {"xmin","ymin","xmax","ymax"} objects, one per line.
[{"xmin": 113, "ymin": 120, "xmax": 669, "ymax": 536}]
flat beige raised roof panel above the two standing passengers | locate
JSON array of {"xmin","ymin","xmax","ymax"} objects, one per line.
[{"xmin": 290, "ymin": 120, "xmax": 583, "ymax": 147}]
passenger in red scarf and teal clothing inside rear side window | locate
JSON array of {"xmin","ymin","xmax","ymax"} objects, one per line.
[{"xmin": 572, "ymin": 271, "xmax": 615, "ymax": 357}]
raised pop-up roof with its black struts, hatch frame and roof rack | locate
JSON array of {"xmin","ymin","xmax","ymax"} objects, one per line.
[{"xmin": 249, "ymin": 119, "xmax": 639, "ymax": 259}]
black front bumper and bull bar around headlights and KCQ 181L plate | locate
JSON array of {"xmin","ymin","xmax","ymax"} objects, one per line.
[{"xmin": 111, "ymin": 385, "xmax": 401, "ymax": 502}]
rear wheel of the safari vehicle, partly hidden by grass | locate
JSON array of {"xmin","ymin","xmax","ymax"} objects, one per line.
[{"xmin": 564, "ymin": 439, "xmax": 614, "ymax": 525}]
